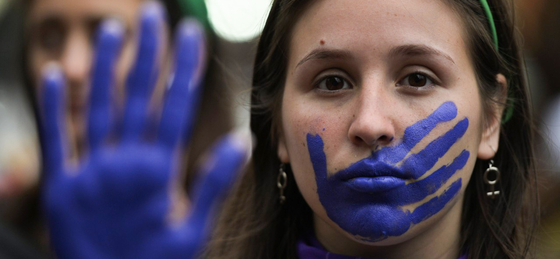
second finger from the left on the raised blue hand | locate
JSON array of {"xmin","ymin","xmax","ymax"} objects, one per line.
[{"xmin": 88, "ymin": 19, "xmax": 124, "ymax": 152}]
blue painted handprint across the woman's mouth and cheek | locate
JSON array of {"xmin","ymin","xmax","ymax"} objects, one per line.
[{"xmin": 307, "ymin": 102, "xmax": 469, "ymax": 241}]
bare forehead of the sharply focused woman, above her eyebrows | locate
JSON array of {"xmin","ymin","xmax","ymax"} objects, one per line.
[{"xmin": 290, "ymin": 0, "xmax": 467, "ymax": 69}]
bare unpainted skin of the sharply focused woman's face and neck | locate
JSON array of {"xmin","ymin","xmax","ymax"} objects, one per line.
[{"xmin": 278, "ymin": 0, "xmax": 507, "ymax": 258}]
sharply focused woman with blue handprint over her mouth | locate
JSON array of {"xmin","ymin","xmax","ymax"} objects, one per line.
[{"xmin": 206, "ymin": 0, "xmax": 537, "ymax": 258}]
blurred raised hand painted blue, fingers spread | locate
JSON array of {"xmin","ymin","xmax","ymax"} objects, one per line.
[{"xmin": 42, "ymin": 3, "xmax": 247, "ymax": 259}]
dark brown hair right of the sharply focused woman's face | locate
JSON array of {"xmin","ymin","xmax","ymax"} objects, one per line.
[{"xmin": 447, "ymin": 0, "xmax": 539, "ymax": 258}]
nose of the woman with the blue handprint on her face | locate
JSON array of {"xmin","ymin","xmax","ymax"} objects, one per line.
[{"xmin": 348, "ymin": 88, "xmax": 395, "ymax": 149}]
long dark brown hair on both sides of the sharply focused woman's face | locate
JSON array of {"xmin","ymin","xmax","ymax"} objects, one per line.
[{"xmin": 204, "ymin": 0, "xmax": 538, "ymax": 258}]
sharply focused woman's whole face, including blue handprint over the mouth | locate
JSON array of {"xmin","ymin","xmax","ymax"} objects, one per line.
[{"xmin": 278, "ymin": 0, "xmax": 499, "ymax": 252}]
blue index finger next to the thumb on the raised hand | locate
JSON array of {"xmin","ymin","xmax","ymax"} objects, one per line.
[{"xmin": 158, "ymin": 20, "xmax": 206, "ymax": 149}]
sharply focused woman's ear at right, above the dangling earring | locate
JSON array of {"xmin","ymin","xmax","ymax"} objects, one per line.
[{"xmin": 477, "ymin": 74, "xmax": 508, "ymax": 160}]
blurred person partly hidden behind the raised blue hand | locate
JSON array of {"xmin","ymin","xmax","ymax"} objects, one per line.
[{"xmin": 3, "ymin": 0, "xmax": 231, "ymax": 256}]
